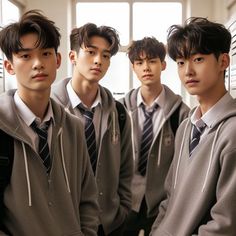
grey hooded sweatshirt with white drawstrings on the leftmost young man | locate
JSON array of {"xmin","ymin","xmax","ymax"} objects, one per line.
[{"xmin": 0, "ymin": 90, "xmax": 98, "ymax": 236}]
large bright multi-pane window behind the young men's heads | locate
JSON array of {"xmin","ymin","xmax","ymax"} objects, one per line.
[{"xmin": 76, "ymin": 0, "xmax": 182, "ymax": 98}]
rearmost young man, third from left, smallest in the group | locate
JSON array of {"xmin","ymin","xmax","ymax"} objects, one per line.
[{"xmin": 122, "ymin": 37, "xmax": 189, "ymax": 236}]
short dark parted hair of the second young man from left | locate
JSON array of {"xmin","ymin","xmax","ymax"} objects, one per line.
[{"xmin": 70, "ymin": 23, "xmax": 120, "ymax": 56}]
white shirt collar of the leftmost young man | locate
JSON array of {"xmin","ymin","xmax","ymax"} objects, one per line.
[{"xmin": 14, "ymin": 91, "xmax": 54, "ymax": 126}]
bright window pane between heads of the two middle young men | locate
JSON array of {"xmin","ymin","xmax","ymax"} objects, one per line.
[{"xmin": 100, "ymin": 52, "xmax": 129, "ymax": 99}]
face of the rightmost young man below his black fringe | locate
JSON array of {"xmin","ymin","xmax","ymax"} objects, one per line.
[{"xmin": 176, "ymin": 53, "xmax": 229, "ymax": 97}]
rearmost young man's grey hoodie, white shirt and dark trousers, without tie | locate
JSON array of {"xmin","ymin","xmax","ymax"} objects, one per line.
[{"xmin": 120, "ymin": 85, "xmax": 189, "ymax": 235}]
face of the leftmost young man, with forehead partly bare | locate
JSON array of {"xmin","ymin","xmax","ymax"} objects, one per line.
[{"xmin": 4, "ymin": 33, "xmax": 61, "ymax": 96}]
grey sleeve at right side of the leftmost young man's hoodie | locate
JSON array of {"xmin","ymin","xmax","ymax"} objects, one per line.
[{"xmin": 79, "ymin": 132, "xmax": 99, "ymax": 236}]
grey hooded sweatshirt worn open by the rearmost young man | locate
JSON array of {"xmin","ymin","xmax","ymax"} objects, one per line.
[{"xmin": 121, "ymin": 85, "xmax": 189, "ymax": 217}]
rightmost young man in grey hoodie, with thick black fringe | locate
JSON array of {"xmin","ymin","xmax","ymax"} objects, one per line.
[{"xmin": 151, "ymin": 18, "xmax": 236, "ymax": 236}]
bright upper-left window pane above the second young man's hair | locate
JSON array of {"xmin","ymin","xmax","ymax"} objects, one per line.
[{"xmin": 76, "ymin": 2, "xmax": 129, "ymax": 45}]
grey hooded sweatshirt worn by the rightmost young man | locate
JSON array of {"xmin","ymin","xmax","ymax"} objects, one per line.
[{"xmin": 150, "ymin": 95, "xmax": 236, "ymax": 236}]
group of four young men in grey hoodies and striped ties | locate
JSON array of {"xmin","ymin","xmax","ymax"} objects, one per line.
[{"xmin": 0, "ymin": 10, "xmax": 236, "ymax": 236}]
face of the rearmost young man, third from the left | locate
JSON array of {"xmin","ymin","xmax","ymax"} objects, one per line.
[{"xmin": 133, "ymin": 53, "xmax": 166, "ymax": 86}]
